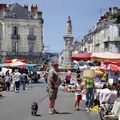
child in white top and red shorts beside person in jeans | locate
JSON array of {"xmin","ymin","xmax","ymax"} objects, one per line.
[{"xmin": 74, "ymin": 74, "xmax": 82, "ymax": 111}]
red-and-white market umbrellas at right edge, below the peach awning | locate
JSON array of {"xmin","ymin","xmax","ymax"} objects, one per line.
[{"xmin": 99, "ymin": 64, "xmax": 120, "ymax": 72}]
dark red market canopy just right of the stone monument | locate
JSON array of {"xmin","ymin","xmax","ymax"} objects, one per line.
[{"xmin": 71, "ymin": 53, "xmax": 92, "ymax": 61}]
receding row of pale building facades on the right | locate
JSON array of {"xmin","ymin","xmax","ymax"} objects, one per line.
[{"xmin": 80, "ymin": 7, "xmax": 120, "ymax": 53}]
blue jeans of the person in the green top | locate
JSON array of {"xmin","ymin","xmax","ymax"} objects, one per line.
[{"xmin": 86, "ymin": 88, "xmax": 94, "ymax": 107}]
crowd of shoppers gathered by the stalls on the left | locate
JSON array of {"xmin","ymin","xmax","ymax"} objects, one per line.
[{"xmin": 0, "ymin": 68, "xmax": 40, "ymax": 93}]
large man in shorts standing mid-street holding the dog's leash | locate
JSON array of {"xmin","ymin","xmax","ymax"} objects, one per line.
[{"xmin": 48, "ymin": 63, "xmax": 59, "ymax": 115}]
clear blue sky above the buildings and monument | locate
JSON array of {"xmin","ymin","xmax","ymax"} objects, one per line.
[{"xmin": 0, "ymin": 0, "xmax": 120, "ymax": 52}]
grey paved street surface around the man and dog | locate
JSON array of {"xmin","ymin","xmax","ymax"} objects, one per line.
[{"xmin": 0, "ymin": 79, "xmax": 100, "ymax": 120}]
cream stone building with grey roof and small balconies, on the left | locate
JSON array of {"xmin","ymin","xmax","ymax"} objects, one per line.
[{"xmin": 0, "ymin": 3, "xmax": 43, "ymax": 63}]
